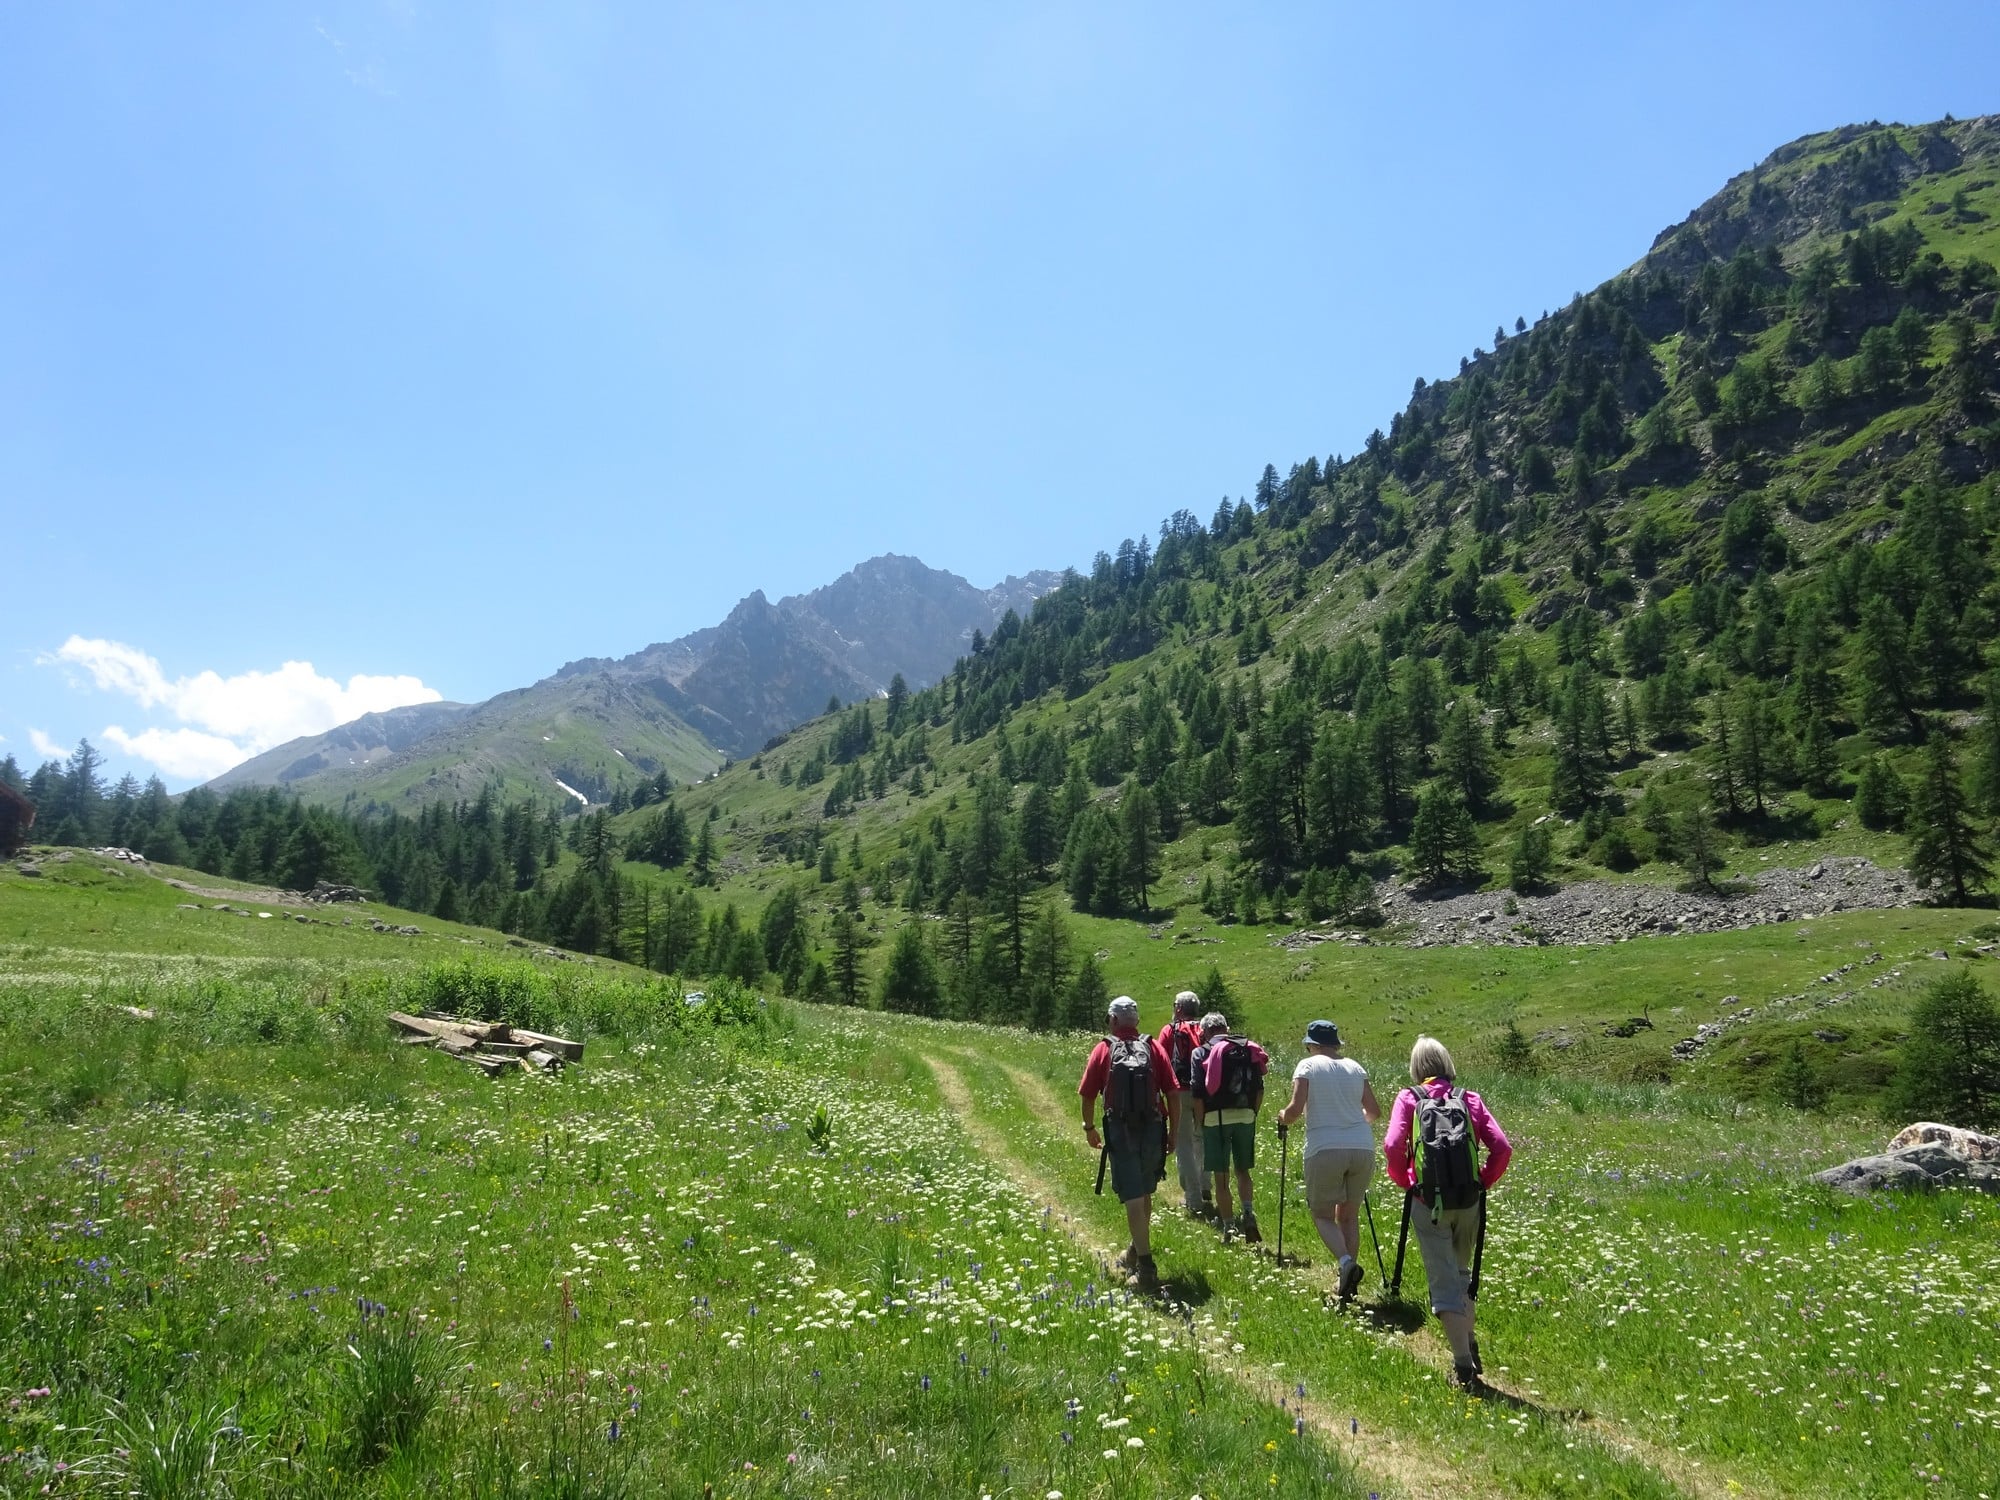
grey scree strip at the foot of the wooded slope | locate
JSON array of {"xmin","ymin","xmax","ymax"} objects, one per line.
[{"xmin": 1376, "ymin": 858, "xmax": 1918, "ymax": 948}]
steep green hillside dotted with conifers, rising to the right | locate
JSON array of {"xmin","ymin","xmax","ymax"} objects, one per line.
[{"xmin": 3, "ymin": 118, "xmax": 2000, "ymax": 1120}]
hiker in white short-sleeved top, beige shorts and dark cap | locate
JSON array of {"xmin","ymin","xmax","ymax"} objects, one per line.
[{"xmin": 1278, "ymin": 1020, "xmax": 1382, "ymax": 1302}]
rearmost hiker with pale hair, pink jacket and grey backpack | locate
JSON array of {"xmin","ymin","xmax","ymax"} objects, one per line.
[{"xmin": 1382, "ymin": 1036, "xmax": 1514, "ymax": 1390}]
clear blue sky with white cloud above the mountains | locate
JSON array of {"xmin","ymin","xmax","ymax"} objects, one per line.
[{"xmin": 0, "ymin": 0, "xmax": 2000, "ymax": 788}]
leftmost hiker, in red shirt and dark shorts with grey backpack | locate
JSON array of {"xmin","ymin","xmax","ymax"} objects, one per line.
[{"xmin": 1076, "ymin": 994, "xmax": 1180, "ymax": 1292}]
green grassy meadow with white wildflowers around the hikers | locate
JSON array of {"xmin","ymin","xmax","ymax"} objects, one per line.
[{"xmin": 0, "ymin": 854, "xmax": 2000, "ymax": 1500}]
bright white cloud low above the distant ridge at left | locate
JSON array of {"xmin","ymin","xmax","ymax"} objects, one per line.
[{"xmin": 36, "ymin": 636, "xmax": 444, "ymax": 778}]
